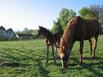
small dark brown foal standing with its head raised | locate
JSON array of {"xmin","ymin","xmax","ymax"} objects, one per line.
[{"xmin": 38, "ymin": 26, "xmax": 60, "ymax": 64}]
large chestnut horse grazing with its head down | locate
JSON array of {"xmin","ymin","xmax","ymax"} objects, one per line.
[{"xmin": 58, "ymin": 16, "xmax": 99, "ymax": 68}]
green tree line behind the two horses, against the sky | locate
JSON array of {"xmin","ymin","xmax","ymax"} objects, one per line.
[{"xmin": 17, "ymin": 5, "xmax": 103, "ymax": 37}]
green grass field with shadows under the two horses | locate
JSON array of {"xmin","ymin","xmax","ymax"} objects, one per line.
[{"xmin": 0, "ymin": 36, "xmax": 103, "ymax": 77}]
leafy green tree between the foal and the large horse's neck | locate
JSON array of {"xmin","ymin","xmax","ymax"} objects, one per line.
[{"xmin": 52, "ymin": 8, "xmax": 76, "ymax": 34}]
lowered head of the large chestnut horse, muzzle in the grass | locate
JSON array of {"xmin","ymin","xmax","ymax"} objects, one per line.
[{"xmin": 58, "ymin": 39, "xmax": 69, "ymax": 68}]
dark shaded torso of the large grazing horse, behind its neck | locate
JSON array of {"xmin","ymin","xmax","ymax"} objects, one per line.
[{"xmin": 75, "ymin": 18, "xmax": 99, "ymax": 40}]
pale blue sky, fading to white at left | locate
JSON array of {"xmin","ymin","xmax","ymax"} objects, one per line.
[{"xmin": 0, "ymin": 0, "xmax": 103, "ymax": 31}]
